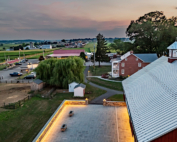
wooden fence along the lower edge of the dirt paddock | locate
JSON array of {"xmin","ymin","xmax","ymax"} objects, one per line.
[{"xmin": 2, "ymin": 96, "xmax": 30, "ymax": 109}]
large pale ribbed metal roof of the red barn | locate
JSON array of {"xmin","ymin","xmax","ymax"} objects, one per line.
[{"xmin": 122, "ymin": 56, "xmax": 177, "ymax": 142}]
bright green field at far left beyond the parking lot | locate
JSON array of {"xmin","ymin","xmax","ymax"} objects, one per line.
[{"xmin": 0, "ymin": 49, "xmax": 56, "ymax": 62}]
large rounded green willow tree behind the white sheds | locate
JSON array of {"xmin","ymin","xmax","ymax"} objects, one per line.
[{"xmin": 36, "ymin": 57, "xmax": 85, "ymax": 89}]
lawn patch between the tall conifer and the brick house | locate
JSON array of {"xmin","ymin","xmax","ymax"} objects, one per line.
[{"xmin": 89, "ymin": 66, "xmax": 111, "ymax": 76}]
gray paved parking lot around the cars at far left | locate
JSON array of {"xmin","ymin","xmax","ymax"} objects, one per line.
[{"xmin": 0, "ymin": 59, "xmax": 37, "ymax": 80}]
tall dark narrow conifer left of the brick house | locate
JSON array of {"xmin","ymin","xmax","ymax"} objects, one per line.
[{"xmin": 95, "ymin": 33, "xmax": 108, "ymax": 67}]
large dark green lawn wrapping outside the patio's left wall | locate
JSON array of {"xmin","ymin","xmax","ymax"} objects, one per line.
[{"xmin": 0, "ymin": 84, "xmax": 106, "ymax": 142}]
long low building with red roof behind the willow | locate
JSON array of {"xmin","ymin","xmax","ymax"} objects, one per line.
[{"xmin": 46, "ymin": 49, "xmax": 85, "ymax": 58}]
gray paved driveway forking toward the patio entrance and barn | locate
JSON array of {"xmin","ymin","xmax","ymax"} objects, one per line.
[{"xmin": 84, "ymin": 67, "xmax": 123, "ymax": 104}]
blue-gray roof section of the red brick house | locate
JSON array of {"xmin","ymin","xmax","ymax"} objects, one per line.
[{"xmin": 134, "ymin": 53, "xmax": 158, "ymax": 63}]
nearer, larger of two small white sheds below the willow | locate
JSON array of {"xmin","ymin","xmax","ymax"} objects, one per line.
[{"xmin": 74, "ymin": 83, "xmax": 86, "ymax": 97}]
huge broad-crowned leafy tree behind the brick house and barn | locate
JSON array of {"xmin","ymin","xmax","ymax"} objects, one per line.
[{"xmin": 126, "ymin": 11, "xmax": 177, "ymax": 55}]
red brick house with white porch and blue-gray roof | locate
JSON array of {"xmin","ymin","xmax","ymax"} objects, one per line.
[{"xmin": 112, "ymin": 51, "xmax": 158, "ymax": 77}]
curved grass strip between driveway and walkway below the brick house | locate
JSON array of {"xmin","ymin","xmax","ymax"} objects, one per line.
[{"xmin": 87, "ymin": 77, "xmax": 123, "ymax": 91}]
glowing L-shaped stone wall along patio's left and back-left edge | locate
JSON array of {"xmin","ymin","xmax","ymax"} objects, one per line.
[{"xmin": 33, "ymin": 99, "xmax": 88, "ymax": 142}]
